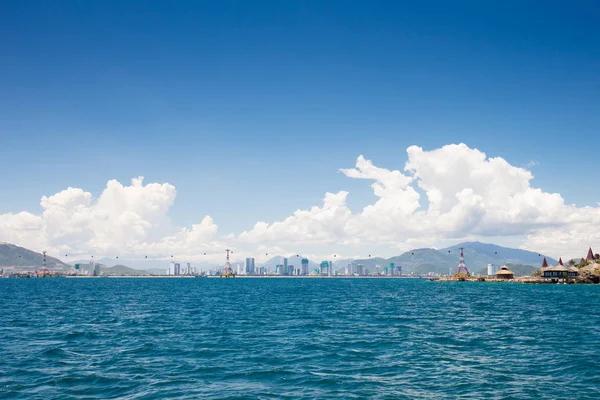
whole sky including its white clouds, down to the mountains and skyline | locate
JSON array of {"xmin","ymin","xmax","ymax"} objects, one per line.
[{"xmin": 0, "ymin": 1, "xmax": 600, "ymax": 262}]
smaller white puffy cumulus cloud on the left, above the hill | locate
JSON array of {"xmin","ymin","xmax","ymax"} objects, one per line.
[{"xmin": 0, "ymin": 177, "xmax": 217, "ymax": 257}]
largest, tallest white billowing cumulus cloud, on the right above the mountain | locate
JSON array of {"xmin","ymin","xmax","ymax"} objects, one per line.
[{"xmin": 240, "ymin": 144, "xmax": 600, "ymax": 260}]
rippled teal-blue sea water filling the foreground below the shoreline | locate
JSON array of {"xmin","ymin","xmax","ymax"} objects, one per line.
[{"xmin": 0, "ymin": 278, "xmax": 600, "ymax": 399}]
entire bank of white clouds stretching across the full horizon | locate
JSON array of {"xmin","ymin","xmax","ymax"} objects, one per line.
[{"xmin": 0, "ymin": 144, "xmax": 600, "ymax": 262}]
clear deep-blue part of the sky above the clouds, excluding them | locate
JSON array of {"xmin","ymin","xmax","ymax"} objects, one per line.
[{"xmin": 0, "ymin": 1, "xmax": 600, "ymax": 260}]
